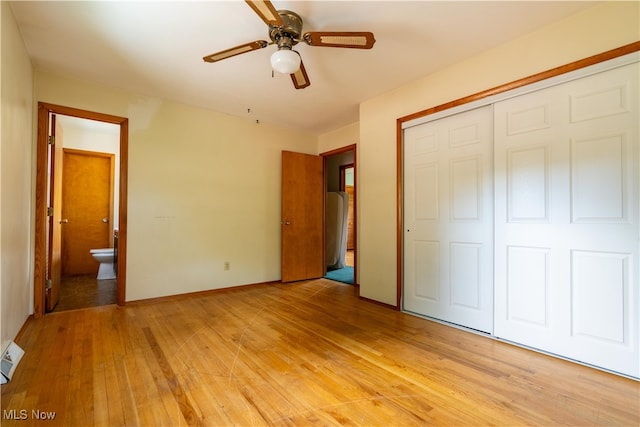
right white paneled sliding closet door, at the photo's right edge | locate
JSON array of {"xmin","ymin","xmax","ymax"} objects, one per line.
[{"xmin": 494, "ymin": 63, "xmax": 640, "ymax": 377}]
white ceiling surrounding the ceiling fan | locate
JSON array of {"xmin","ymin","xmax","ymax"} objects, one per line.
[{"xmin": 11, "ymin": 0, "xmax": 594, "ymax": 135}]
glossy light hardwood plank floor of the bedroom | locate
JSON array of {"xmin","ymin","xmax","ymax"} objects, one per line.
[{"xmin": 2, "ymin": 280, "xmax": 640, "ymax": 426}]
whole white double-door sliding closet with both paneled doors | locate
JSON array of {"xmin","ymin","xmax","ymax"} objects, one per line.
[{"xmin": 402, "ymin": 53, "xmax": 640, "ymax": 378}]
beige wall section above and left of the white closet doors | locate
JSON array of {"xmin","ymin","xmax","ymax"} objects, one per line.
[{"xmin": 358, "ymin": 2, "xmax": 640, "ymax": 305}]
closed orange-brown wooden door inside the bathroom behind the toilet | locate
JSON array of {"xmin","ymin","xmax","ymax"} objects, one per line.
[{"xmin": 62, "ymin": 150, "xmax": 114, "ymax": 276}]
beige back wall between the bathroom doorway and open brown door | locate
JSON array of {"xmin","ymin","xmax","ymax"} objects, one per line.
[{"xmin": 35, "ymin": 72, "xmax": 317, "ymax": 301}]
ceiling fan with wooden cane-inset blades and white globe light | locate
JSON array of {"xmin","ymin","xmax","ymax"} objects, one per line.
[{"xmin": 202, "ymin": 0, "xmax": 376, "ymax": 89}]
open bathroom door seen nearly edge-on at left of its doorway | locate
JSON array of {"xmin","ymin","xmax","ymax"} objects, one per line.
[{"xmin": 45, "ymin": 115, "xmax": 64, "ymax": 311}]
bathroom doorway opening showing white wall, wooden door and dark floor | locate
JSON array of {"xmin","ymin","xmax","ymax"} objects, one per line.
[{"xmin": 51, "ymin": 120, "xmax": 120, "ymax": 312}]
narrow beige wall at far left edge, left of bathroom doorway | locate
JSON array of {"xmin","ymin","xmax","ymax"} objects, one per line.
[{"xmin": 0, "ymin": 2, "xmax": 34, "ymax": 347}]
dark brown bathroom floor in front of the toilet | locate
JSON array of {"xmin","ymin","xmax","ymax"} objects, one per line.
[{"xmin": 53, "ymin": 274, "xmax": 117, "ymax": 313}]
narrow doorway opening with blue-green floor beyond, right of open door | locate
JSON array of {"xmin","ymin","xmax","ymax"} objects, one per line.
[{"xmin": 321, "ymin": 144, "xmax": 357, "ymax": 286}]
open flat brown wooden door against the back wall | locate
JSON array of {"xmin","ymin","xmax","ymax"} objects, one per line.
[{"xmin": 281, "ymin": 151, "xmax": 326, "ymax": 282}]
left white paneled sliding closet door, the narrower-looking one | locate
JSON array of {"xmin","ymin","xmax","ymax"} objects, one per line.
[{"xmin": 403, "ymin": 106, "xmax": 493, "ymax": 333}]
